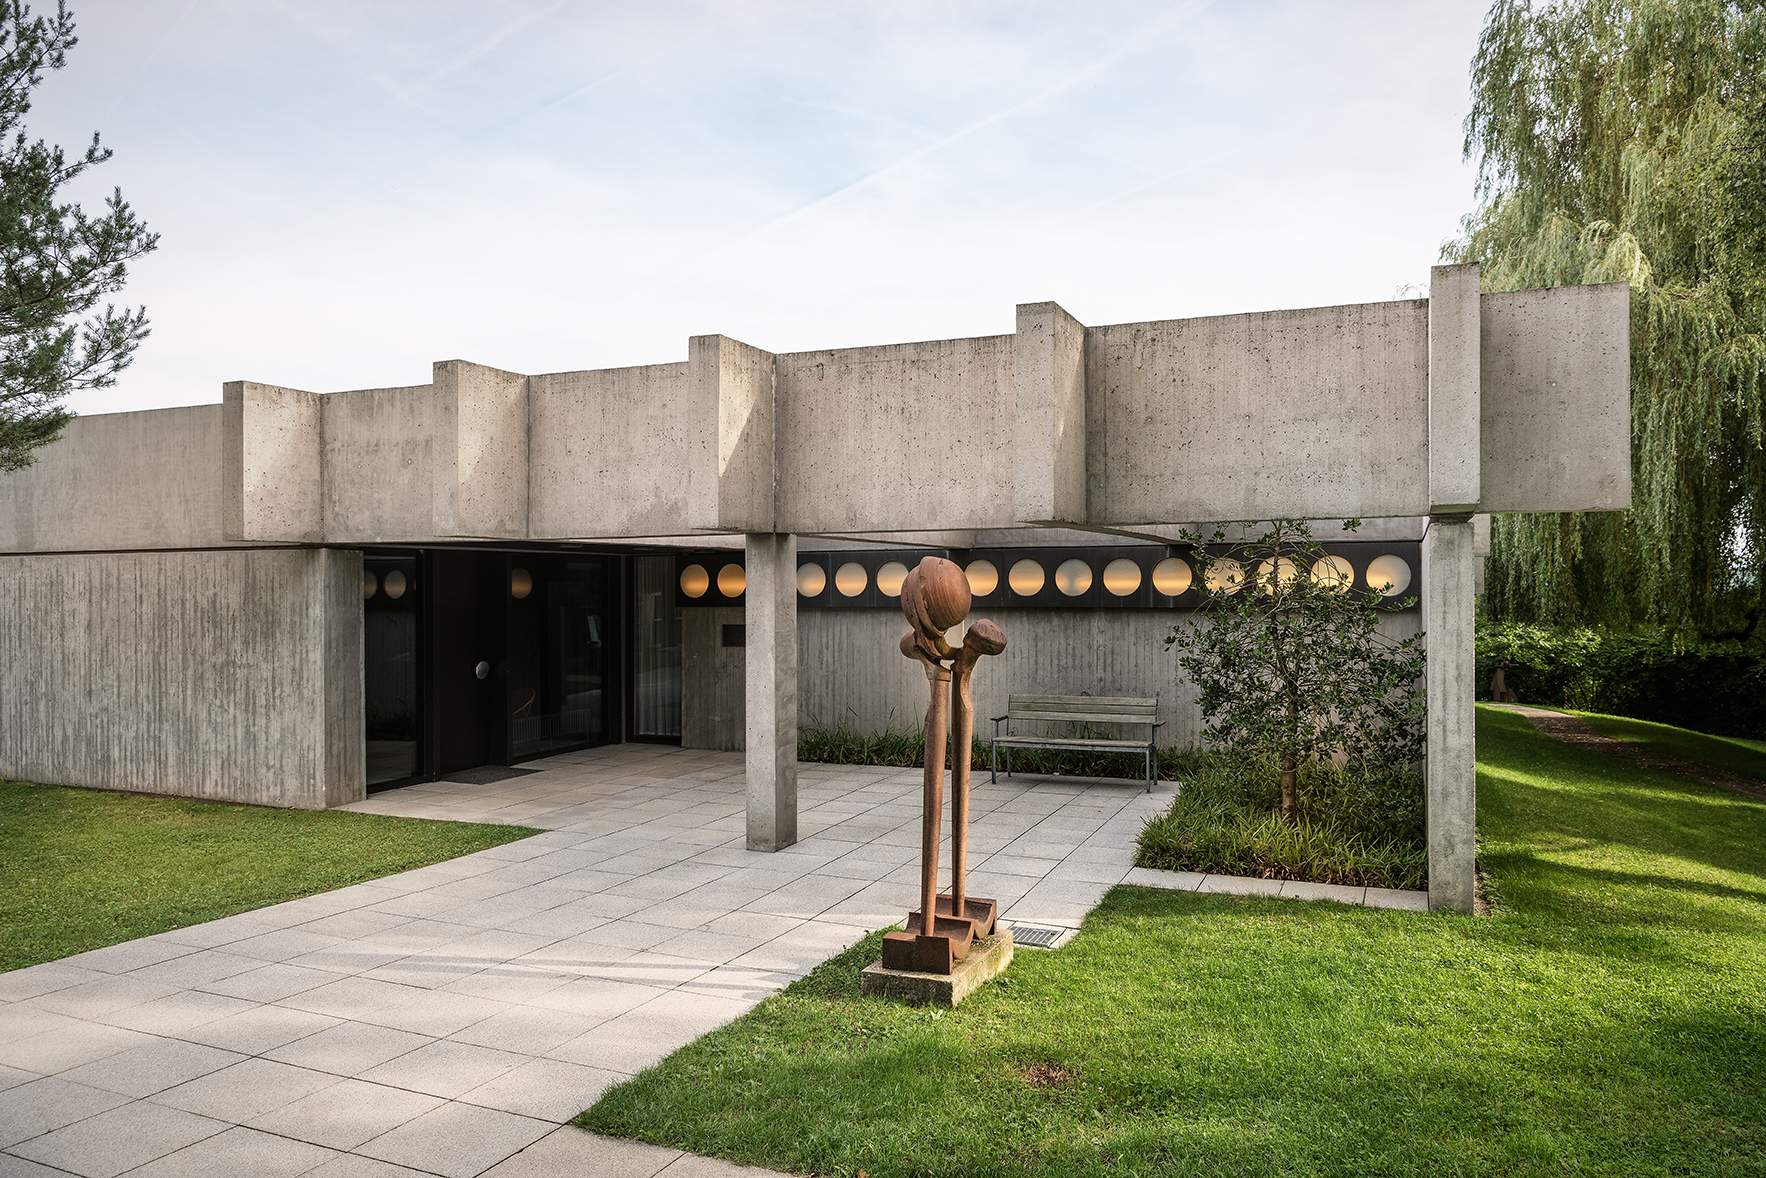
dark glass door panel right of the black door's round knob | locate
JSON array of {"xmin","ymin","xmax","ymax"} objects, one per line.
[{"xmin": 509, "ymin": 553, "xmax": 618, "ymax": 759}]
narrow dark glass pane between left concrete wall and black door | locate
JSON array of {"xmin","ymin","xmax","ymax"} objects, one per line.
[{"xmin": 362, "ymin": 555, "xmax": 422, "ymax": 789}]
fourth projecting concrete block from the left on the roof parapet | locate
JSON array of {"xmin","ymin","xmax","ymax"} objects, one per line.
[{"xmin": 1012, "ymin": 302, "xmax": 1086, "ymax": 523}]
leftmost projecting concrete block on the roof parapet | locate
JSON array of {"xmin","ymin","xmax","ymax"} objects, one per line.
[{"xmin": 221, "ymin": 380, "xmax": 325, "ymax": 542}]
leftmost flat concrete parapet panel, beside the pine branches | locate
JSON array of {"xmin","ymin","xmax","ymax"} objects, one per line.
[{"xmin": 0, "ymin": 404, "xmax": 226, "ymax": 553}]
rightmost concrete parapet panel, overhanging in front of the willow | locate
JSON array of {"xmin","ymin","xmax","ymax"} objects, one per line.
[{"xmin": 1480, "ymin": 283, "xmax": 1632, "ymax": 512}]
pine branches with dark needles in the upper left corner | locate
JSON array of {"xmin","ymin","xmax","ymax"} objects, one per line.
[{"xmin": 0, "ymin": 0, "xmax": 159, "ymax": 470}]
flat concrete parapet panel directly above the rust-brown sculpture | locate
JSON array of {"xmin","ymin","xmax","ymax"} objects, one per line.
[{"xmin": 775, "ymin": 336, "xmax": 1017, "ymax": 532}]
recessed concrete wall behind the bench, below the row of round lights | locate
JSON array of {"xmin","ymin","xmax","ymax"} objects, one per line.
[{"xmin": 682, "ymin": 608, "xmax": 1422, "ymax": 749}]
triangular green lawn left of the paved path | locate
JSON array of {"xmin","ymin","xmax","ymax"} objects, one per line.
[{"xmin": 0, "ymin": 781, "xmax": 537, "ymax": 970}]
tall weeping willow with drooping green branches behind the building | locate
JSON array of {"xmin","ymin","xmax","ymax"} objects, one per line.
[{"xmin": 1446, "ymin": 0, "xmax": 1766, "ymax": 636}]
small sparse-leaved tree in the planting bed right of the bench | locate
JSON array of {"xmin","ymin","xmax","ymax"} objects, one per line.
[{"xmin": 1166, "ymin": 519, "xmax": 1425, "ymax": 819}]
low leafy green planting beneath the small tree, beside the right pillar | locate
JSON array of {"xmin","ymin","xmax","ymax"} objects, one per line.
[{"xmin": 1136, "ymin": 752, "xmax": 1427, "ymax": 888}]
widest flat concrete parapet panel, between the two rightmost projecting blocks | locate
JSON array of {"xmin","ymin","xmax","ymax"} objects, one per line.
[{"xmin": 1086, "ymin": 300, "xmax": 1429, "ymax": 523}]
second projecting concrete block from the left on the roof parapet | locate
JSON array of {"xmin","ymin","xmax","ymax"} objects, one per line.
[{"xmin": 431, "ymin": 360, "xmax": 528, "ymax": 539}]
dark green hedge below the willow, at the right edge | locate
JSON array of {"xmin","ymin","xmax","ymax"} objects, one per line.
[{"xmin": 1478, "ymin": 622, "xmax": 1766, "ymax": 736}]
